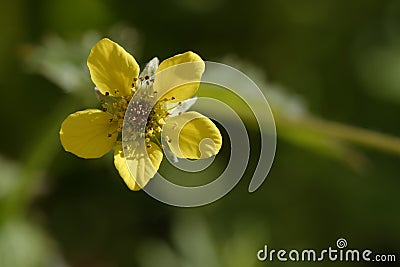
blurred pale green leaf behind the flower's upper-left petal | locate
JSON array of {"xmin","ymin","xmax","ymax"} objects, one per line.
[{"xmin": 21, "ymin": 24, "xmax": 141, "ymax": 106}]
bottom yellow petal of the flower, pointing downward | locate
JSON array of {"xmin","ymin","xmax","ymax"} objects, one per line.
[{"xmin": 114, "ymin": 142, "xmax": 163, "ymax": 191}]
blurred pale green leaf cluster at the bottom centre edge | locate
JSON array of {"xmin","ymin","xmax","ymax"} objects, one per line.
[{"xmin": 137, "ymin": 214, "xmax": 267, "ymax": 267}]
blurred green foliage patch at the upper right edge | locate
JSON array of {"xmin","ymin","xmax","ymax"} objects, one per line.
[{"xmin": 354, "ymin": 1, "xmax": 400, "ymax": 103}]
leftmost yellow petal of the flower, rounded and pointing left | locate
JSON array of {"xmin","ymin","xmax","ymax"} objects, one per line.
[{"xmin": 60, "ymin": 109, "xmax": 118, "ymax": 158}]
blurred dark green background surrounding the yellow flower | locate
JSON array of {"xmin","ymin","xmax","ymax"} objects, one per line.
[{"xmin": 0, "ymin": 0, "xmax": 400, "ymax": 267}]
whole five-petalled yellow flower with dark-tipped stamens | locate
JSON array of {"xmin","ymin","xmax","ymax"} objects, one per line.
[{"xmin": 60, "ymin": 38, "xmax": 222, "ymax": 190}]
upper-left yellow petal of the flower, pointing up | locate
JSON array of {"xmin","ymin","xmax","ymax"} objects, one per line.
[{"xmin": 87, "ymin": 38, "xmax": 139, "ymax": 96}]
